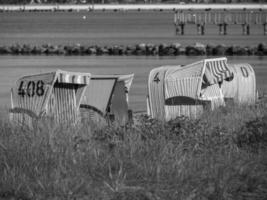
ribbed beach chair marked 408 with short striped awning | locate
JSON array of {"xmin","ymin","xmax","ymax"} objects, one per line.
[{"xmin": 10, "ymin": 70, "xmax": 91, "ymax": 124}]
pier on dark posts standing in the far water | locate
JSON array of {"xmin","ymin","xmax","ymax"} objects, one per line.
[{"xmin": 174, "ymin": 10, "xmax": 267, "ymax": 35}]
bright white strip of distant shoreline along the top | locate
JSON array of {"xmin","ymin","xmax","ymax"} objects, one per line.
[{"xmin": 0, "ymin": 4, "xmax": 267, "ymax": 11}]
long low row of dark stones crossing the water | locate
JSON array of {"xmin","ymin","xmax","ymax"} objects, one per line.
[{"xmin": 0, "ymin": 43, "xmax": 267, "ymax": 56}]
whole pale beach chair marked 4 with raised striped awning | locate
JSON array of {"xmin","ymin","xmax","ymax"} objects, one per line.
[{"xmin": 148, "ymin": 58, "xmax": 232, "ymax": 120}]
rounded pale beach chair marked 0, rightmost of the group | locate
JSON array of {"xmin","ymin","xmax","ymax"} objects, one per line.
[{"xmin": 222, "ymin": 64, "xmax": 257, "ymax": 104}]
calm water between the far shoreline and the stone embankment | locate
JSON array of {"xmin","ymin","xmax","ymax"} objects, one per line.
[{"xmin": 0, "ymin": 11, "xmax": 267, "ymax": 46}]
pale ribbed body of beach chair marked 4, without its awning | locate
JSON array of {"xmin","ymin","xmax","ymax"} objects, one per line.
[{"xmin": 147, "ymin": 65, "xmax": 204, "ymax": 120}]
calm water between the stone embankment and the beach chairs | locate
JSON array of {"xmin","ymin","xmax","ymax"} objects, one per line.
[{"xmin": 0, "ymin": 56, "xmax": 267, "ymax": 111}]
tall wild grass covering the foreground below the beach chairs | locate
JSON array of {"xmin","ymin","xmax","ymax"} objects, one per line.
[{"xmin": 0, "ymin": 101, "xmax": 267, "ymax": 200}]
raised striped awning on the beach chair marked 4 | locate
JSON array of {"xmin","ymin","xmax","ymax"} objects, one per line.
[{"xmin": 205, "ymin": 59, "xmax": 233, "ymax": 85}]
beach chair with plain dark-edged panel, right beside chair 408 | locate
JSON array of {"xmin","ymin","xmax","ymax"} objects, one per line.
[{"xmin": 80, "ymin": 74, "xmax": 134, "ymax": 124}]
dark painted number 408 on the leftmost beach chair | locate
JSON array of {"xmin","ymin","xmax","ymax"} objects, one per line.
[{"xmin": 18, "ymin": 80, "xmax": 44, "ymax": 97}]
